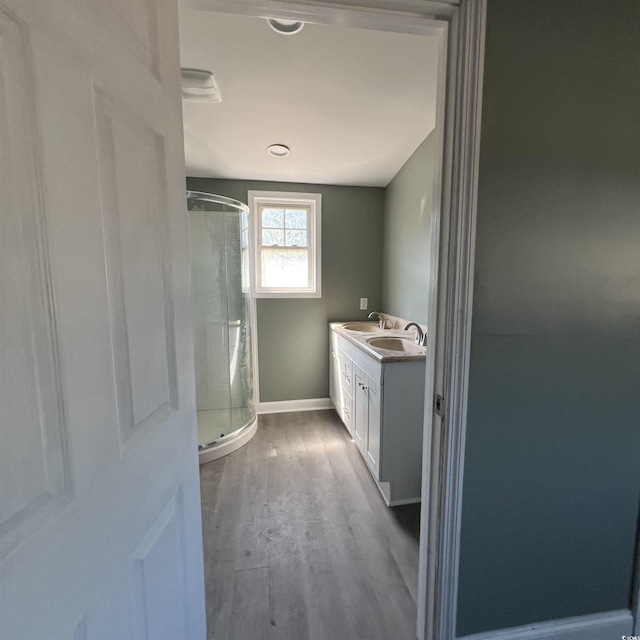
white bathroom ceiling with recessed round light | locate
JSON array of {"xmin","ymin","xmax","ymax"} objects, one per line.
[{"xmin": 180, "ymin": 9, "xmax": 438, "ymax": 186}]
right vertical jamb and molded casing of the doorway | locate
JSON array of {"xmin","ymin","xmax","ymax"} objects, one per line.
[{"xmin": 418, "ymin": 5, "xmax": 486, "ymax": 640}]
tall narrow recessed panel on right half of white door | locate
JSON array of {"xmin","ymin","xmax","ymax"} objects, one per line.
[{"xmin": 94, "ymin": 86, "xmax": 178, "ymax": 447}]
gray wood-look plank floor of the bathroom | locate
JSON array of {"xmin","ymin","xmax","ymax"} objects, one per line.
[{"xmin": 200, "ymin": 411, "xmax": 419, "ymax": 640}]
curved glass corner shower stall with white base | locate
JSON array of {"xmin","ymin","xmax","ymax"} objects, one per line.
[{"xmin": 187, "ymin": 191, "xmax": 257, "ymax": 464}]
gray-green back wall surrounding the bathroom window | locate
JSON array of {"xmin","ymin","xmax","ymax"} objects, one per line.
[{"xmin": 187, "ymin": 178, "xmax": 384, "ymax": 402}]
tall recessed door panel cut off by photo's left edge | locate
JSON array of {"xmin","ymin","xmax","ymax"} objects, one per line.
[{"xmin": 0, "ymin": 4, "xmax": 72, "ymax": 559}]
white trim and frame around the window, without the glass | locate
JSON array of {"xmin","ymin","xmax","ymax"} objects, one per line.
[{"xmin": 247, "ymin": 191, "xmax": 322, "ymax": 298}]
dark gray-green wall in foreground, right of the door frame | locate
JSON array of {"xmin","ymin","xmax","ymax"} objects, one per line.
[{"xmin": 458, "ymin": 0, "xmax": 640, "ymax": 636}]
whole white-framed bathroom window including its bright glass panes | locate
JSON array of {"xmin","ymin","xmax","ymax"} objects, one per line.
[{"xmin": 249, "ymin": 191, "xmax": 321, "ymax": 298}]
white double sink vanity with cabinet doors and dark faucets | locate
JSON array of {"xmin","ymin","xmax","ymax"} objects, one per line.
[{"xmin": 329, "ymin": 322, "xmax": 427, "ymax": 506}]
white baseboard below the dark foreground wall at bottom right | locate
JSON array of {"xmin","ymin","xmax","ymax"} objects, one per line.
[{"xmin": 458, "ymin": 609, "xmax": 633, "ymax": 640}]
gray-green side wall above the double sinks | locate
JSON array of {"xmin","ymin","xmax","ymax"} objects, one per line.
[{"xmin": 382, "ymin": 132, "xmax": 436, "ymax": 324}]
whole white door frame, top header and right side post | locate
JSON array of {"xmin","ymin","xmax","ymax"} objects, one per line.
[{"xmin": 181, "ymin": 0, "xmax": 487, "ymax": 640}]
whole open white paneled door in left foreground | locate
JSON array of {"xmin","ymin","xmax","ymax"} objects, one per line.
[{"xmin": 0, "ymin": 0, "xmax": 205, "ymax": 640}]
